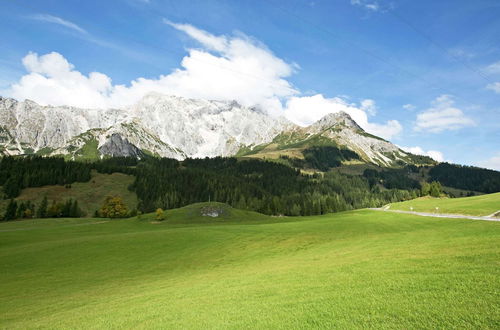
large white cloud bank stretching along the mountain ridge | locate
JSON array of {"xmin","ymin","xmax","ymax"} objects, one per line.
[{"xmin": 0, "ymin": 20, "xmax": 402, "ymax": 139}]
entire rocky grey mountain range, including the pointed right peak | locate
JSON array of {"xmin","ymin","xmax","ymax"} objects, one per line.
[{"xmin": 0, "ymin": 93, "xmax": 433, "ymax": 167}]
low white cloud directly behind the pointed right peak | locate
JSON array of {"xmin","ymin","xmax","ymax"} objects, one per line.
[{"xmin": 285, "ymin": 94, "xmax": 403, "ymax": 139}]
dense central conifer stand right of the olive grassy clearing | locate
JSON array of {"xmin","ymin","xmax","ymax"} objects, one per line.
[{"xmin": 130, "ymin": 157, "xmax": 417, "ymax": 215}]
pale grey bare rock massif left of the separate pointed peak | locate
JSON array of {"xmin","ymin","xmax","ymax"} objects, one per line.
[{"xmin": 0, "ymin": 93, "xmax": 293, "ymax": 159}]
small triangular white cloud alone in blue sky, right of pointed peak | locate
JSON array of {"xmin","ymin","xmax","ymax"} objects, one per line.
[{"xmin": 415, "ymin": 95, "xmax": 475, "ymax": 133}]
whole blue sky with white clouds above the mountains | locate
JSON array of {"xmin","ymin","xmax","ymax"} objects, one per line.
[{"xmin": 0, "ymin": 0, "xmax": 500, "ymax": 170}]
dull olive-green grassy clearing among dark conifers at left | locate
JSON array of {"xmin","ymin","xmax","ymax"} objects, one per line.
[{"xmin": 0, "ymin": 171, "xmax": 137, "ymax": 217}]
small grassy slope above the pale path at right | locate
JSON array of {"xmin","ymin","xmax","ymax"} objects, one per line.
[{"xmin": 390, "ymin": 193, "xmax": 500, "ymax": 216}]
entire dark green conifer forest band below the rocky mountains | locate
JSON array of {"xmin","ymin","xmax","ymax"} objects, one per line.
[{"xmin": 0, "ymin": 155, "xmax": 500, "ymax": 219}]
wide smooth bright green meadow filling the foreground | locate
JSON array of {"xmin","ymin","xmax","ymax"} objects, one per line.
[{"xmin": 0, "ymin": 204, "xmax": 500, "ymax": 329}]
